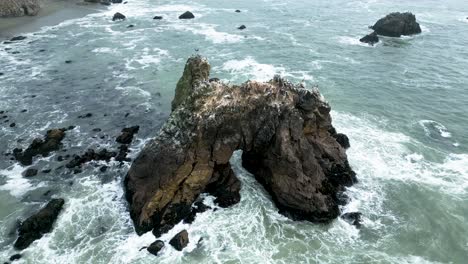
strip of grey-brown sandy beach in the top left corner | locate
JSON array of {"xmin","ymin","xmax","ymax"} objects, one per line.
[{"xmin": 0, "ymin": 0, "xmax": 107, "ymax": 40}]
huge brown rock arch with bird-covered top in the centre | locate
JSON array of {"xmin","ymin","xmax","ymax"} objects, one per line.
[{"xmin": 125, "ymin": 56, "xmax": 356, "ymax": 234}]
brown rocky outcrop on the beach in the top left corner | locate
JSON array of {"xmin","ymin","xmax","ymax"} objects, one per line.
[{"xmin": 0, "ymin": 0, "xmax": 41, "ymax": 17}]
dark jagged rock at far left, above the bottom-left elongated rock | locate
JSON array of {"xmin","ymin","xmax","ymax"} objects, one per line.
[{"xmin": 13, "ymin": 128, "xmax": 67, "ymax": 166}]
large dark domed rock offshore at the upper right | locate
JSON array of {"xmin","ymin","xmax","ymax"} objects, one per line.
[{"xmin": 370, "ymin": 12, "xmax": 421, "ymax": 37}]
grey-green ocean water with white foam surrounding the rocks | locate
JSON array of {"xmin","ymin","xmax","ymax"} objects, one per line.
[{"xmin": 0, "ymin": 0, "xmax": 468, "ymax": 263}]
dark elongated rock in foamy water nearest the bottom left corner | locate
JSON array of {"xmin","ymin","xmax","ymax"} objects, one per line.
[{"xmin": 14, "ymin": 199, "xmax": 65, "ymax": 250}]
